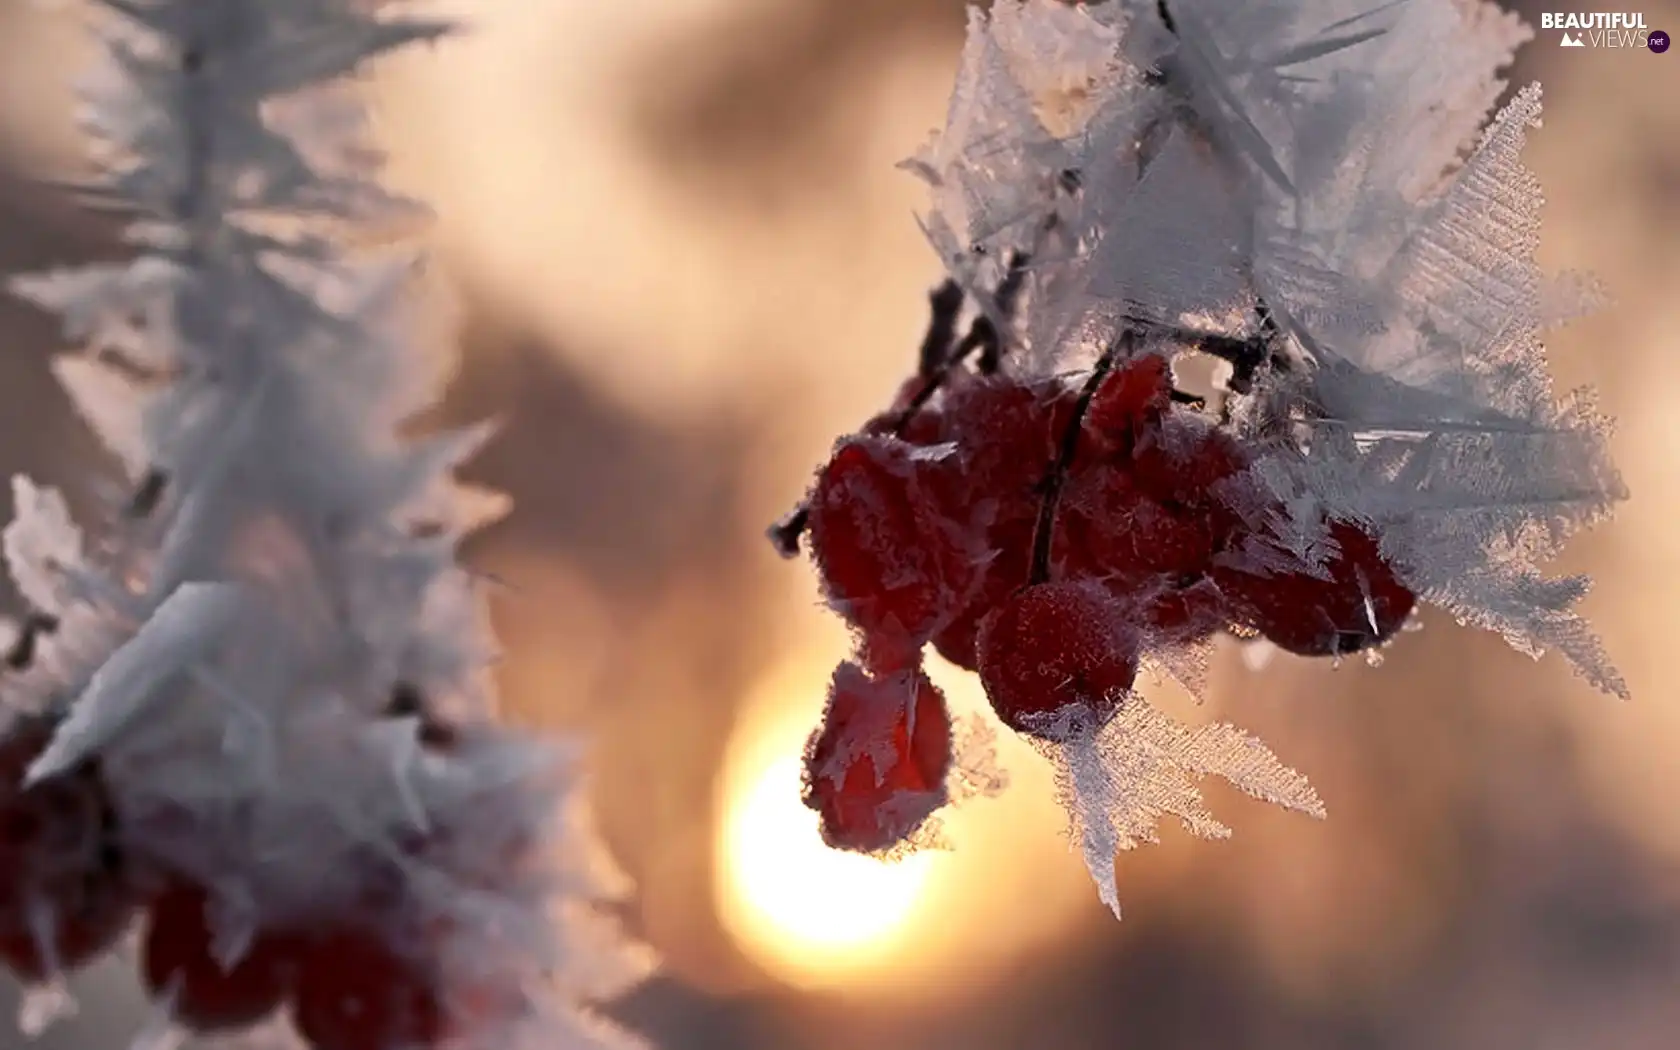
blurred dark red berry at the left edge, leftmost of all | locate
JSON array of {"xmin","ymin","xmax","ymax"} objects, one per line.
[{"xmin": 0, "ymin": 717, "xmax": 141, "ymax": 981}]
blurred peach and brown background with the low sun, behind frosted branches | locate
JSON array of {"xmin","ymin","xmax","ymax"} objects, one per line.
[{"xmin": 0, "ymin": 0, "xmax": 1680, "ymax": 1050}]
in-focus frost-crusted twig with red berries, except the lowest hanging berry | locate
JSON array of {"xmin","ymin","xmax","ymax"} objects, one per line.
[{"xmin": 771, "ymin": 0, "xmax": 1626, "ymax": 911}]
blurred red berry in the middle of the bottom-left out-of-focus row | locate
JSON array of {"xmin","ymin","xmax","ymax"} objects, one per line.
[{"xmin": 141, "ymin": 885, "xmax": 301, "ymax": 1033}]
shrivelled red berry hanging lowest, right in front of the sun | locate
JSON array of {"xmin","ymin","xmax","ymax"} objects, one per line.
[{"xmin": 805, "ymin": 662, "xmax": 951, "ymax": 853}]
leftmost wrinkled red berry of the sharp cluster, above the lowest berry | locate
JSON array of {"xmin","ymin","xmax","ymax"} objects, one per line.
[{"xmin": 810, "ymin": 437, "xmax": 979, "ymax": 670}]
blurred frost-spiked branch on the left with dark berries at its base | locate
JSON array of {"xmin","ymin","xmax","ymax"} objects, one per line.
[{"xmin": 0, "ymin": 0, "xmax": 645, "ymax": 1050}]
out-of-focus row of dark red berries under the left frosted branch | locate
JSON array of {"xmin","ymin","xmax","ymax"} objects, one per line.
[{"xmin": 0, "ymin": 695, "xmax": 521, "ymax": 1050}]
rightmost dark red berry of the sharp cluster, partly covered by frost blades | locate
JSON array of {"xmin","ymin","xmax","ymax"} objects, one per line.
[{"xmin": 1213, "ymin": 521, "xmax": 1416, "ymax": 657}]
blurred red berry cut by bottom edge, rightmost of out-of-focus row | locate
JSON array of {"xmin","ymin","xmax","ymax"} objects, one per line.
[{"xmin": 292, "ymin": 927, "xmax": 447, "ymax": 1050}]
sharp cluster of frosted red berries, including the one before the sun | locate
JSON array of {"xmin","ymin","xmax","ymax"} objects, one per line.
[{"xmin": 773, "ymin": 286, "xmax": 1415, "ymax": 852}]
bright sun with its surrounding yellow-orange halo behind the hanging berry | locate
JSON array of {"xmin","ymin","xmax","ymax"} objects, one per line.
[{"xmin": 716, "ymin": 635, "xmax": 1097, "ymax": 1000}]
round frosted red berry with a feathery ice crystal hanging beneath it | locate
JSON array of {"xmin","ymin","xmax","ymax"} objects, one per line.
[{"xmin": 978, "ymin": 580, "xmax": 1142, "ymax": 739}]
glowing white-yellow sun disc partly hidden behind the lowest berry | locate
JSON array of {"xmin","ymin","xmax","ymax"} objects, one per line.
[{"xmin": 717, "ymin": 658, "xmax": 931, "ymax": 986}]
